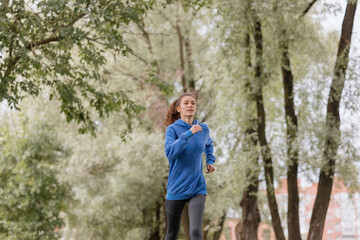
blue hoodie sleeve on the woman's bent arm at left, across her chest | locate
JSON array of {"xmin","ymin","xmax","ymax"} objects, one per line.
[{"xmin": 165, "ymin": 127, "xmax": 193, "ymax": 161}]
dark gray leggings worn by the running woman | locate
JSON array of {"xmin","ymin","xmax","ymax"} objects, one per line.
[{"xmin": 165, "ymin": 194, "xmax": 206, "ymax": 240}]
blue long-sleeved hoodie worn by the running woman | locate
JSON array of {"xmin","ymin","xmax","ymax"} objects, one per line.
[{"xmin": 165, "ymin": 119, "xmax": 215, "ymax": 200}]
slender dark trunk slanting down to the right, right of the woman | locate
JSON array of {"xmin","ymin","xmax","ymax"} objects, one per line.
[{"xmin": 254, "ymin": 16, "xmax": 285, "ymax": 240}]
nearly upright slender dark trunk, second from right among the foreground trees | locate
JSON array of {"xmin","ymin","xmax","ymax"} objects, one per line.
[{"xmin": 280, "ymin": 30, "xmax": 301, "ymax": 240}]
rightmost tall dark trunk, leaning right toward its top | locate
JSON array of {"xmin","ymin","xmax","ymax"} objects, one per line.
[{"xmin": 308, "ymin": 0, "xmax": 357, "ymax": 240}]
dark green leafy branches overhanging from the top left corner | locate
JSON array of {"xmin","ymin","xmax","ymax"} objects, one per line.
[{"xmin": 0, "ymin": 0, "xmax": 154, "ymax": 134}]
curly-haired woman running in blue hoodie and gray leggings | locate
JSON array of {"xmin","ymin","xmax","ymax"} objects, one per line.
[{"xmin": 165, "ymin": 93, "xmax": 215, "ymax": 240}]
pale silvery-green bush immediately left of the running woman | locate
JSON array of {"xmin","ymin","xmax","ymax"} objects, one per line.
[{"xmin": 58, "ymin": 125, "xmax": 167, "ymax": 240}]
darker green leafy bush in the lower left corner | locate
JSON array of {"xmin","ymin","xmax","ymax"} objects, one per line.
[{"xmin": 0, "ymin": 124, "xmax": 68, "ymax": 240}]
